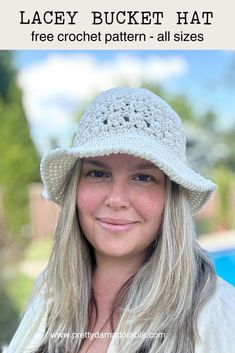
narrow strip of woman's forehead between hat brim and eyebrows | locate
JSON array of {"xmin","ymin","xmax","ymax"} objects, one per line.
[{"xmin": 83, "ymin": 153, "xmax": 158, "ymax": 169}]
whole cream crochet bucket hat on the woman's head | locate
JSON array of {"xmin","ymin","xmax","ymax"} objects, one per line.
[{"xmin": 41, "ymin": 87, "xmax": 216, "ymax": 213}]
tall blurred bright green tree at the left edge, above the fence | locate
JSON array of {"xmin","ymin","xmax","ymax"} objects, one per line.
[{"xmin": 0, "ymin": 51, "xmax": 39, "ymax": 239}]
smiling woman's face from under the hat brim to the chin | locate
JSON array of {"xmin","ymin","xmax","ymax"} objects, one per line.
[{"xmin": 77, "ymin": 154, "xmax": 166, "ymax": 259}]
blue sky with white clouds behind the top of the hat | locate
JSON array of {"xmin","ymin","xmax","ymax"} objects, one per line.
[{"xmin": 14, "ymin": 50, "xmax": 235, "ymax": 154}]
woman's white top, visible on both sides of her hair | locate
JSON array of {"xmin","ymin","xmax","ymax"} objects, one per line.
[{"xmin": 4, "ymin": 278, "xmax": 235, "ymax": 353}]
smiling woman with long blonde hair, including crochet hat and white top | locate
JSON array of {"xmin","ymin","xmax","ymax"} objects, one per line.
[{"xmin": 7, "ymin": 88, "xmax": 235, "ymax": 353}]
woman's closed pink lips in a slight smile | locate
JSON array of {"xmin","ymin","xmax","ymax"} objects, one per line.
[{"xmin": 97, "ymin": 218, "xmax": 138, "ymax": 232}]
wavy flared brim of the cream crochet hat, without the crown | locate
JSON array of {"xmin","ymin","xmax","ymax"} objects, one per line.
[{"xmin": 40, "ymin": 133, "xmax": 216, "ymax": 213}]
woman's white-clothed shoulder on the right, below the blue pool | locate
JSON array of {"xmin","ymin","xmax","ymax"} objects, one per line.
[{"xmin": 195, "ymin": 277, "xmax": 235, "ymax": 353}]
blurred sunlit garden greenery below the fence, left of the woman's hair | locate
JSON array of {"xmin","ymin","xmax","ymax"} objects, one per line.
[{"xmin": 0, "ymin": 238, "xmax": 52, "ymax": 346}]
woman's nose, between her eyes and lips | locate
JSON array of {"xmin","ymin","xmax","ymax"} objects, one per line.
[{"xmin": 105, "ymin": 180, "xmax": 130, "ymax": 210}]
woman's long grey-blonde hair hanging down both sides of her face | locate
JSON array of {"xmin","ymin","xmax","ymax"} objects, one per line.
[{"xmin": 34, "ymin": 161, "xmax": 216, "ymax": 353}]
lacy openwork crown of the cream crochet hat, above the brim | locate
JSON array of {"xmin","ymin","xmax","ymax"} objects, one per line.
[{"xmin": 75, "ymin": 88, "xmax": 186, "ymax": 160}]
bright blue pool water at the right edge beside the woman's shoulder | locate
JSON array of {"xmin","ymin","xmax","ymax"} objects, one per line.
[{"xmin": 209, "ymin": 249, "xmax": 235, "ymax": 286}]
